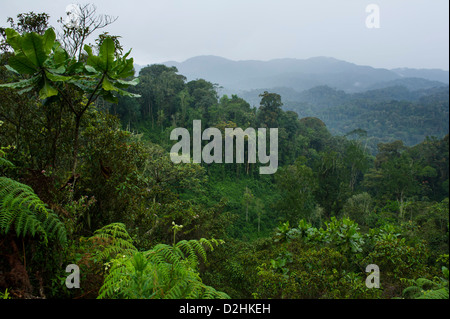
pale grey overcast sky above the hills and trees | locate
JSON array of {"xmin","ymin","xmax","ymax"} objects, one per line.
[{"xmin": 0, "ymin": 0, "xmax": 449, "ymax": 70}]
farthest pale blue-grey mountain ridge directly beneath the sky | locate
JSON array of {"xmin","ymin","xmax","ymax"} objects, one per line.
[{"xmin": 157, "ymin": 56, "xmax": 449, "ymax": 94}]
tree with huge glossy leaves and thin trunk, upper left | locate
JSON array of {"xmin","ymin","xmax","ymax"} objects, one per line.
[{"xmin": 0, "ymin": 28, "xmax": 138, "ymax": 188}]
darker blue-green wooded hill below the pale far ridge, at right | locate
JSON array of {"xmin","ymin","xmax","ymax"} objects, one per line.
[{"xmin": 283, "ymin": 86, "xmax": 449, "ymax": 152}]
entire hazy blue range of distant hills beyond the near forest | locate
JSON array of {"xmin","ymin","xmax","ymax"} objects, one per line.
[{"xmin": 137, "ymin": 56, "xmax": 449, "ymax": 153}]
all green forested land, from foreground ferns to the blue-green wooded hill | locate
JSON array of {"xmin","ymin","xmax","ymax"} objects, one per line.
[{"xmin": 0, "ymin": 9, "xmax": 449, "ymax": 299}]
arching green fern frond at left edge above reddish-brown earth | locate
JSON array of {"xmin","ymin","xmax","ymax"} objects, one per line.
[{"xmin": 0, "ymin": 177, "xmax": 67, "ymax": 244}]
